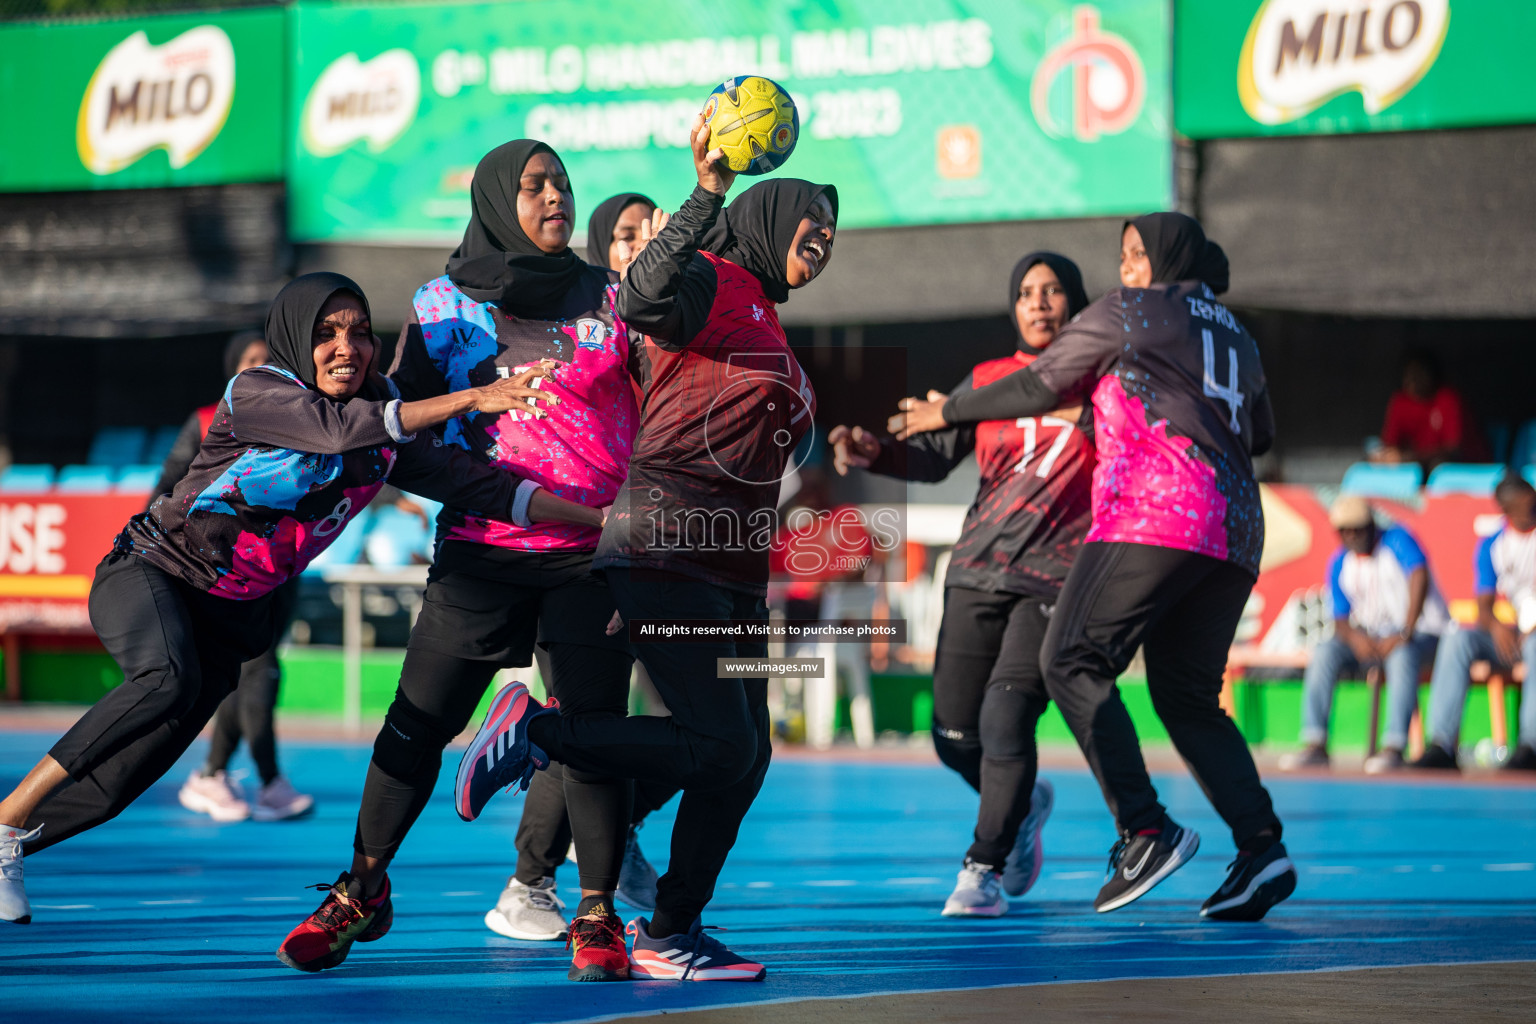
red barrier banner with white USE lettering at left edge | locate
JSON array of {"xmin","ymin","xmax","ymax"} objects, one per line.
[{"xmin": 0, "ymin": 493, "xmax": 147, "ymax": 633}]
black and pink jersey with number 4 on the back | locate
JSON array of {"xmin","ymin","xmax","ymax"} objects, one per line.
[{"xmin": 945, "ymin": 281, "xmax": 1275, "ymax": 574}]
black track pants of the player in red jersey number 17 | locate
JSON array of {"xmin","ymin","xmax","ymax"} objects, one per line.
[{"xmin": 934, "ymin": 586, "xmax": 1051, "ymax": 870}]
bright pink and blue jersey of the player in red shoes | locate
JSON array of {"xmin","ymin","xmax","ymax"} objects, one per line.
[{"xmin": 390, "ymin": 266, "xmax": 639, "ymax": 551}]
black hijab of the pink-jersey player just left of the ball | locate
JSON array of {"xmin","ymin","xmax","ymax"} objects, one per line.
[{"xmin": 447, "ymin": 138, "xmax": 586, "ymax": 319}]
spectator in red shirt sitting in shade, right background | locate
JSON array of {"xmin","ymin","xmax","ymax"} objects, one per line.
[{"xmin": 1370, "ymin": 352, "xmax": 1488, "ymax": 473}]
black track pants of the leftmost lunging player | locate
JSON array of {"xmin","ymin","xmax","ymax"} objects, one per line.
[{"xmin": 25, "ymin": 551, "xmax": 272, "ymax": 854}]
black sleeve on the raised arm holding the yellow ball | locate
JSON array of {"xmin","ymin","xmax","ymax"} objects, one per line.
[{"xmin": 614, "ymin": 186, "xmax": 725, "ymax": 352}]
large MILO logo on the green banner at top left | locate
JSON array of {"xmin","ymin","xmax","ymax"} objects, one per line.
[{"xmin": 75, "ymin": 25, "xmax": 235, "ymax": 175}]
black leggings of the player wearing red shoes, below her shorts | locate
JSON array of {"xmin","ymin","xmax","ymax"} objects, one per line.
[{"xmin": 353, "ymin": 643, "xmax": 633, "ymax": 892}]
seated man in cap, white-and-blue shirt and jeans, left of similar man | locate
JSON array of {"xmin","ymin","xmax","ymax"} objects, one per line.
[{"xmin": 1279, "ymin": 494, "xmax": 1450, "ymax": 775}]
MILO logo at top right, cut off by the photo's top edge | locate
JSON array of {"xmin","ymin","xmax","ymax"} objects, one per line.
[{"xmin": 1238, "ymin": 0, "xmax": 1450, "ymax": 124}]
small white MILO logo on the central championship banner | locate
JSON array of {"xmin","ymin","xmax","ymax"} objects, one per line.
[{"xmin": 303, "ymin": 49, "xmax": 421, "ymax": 157}]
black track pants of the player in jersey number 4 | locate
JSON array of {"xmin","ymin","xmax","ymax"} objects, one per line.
[{"xmin": 1041, "ymin": 542, "xmax": 1279, "ymax": 847}]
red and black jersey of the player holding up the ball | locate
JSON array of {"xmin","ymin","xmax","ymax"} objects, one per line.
[{"xmin": 593, "ymin": 189, "xmax": 816, "ymax": 594}]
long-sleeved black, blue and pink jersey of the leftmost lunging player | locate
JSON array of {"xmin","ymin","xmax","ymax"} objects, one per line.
[{"xmin": 117, "ymin": 365, "xmax": 521, "ymax": 600}]
